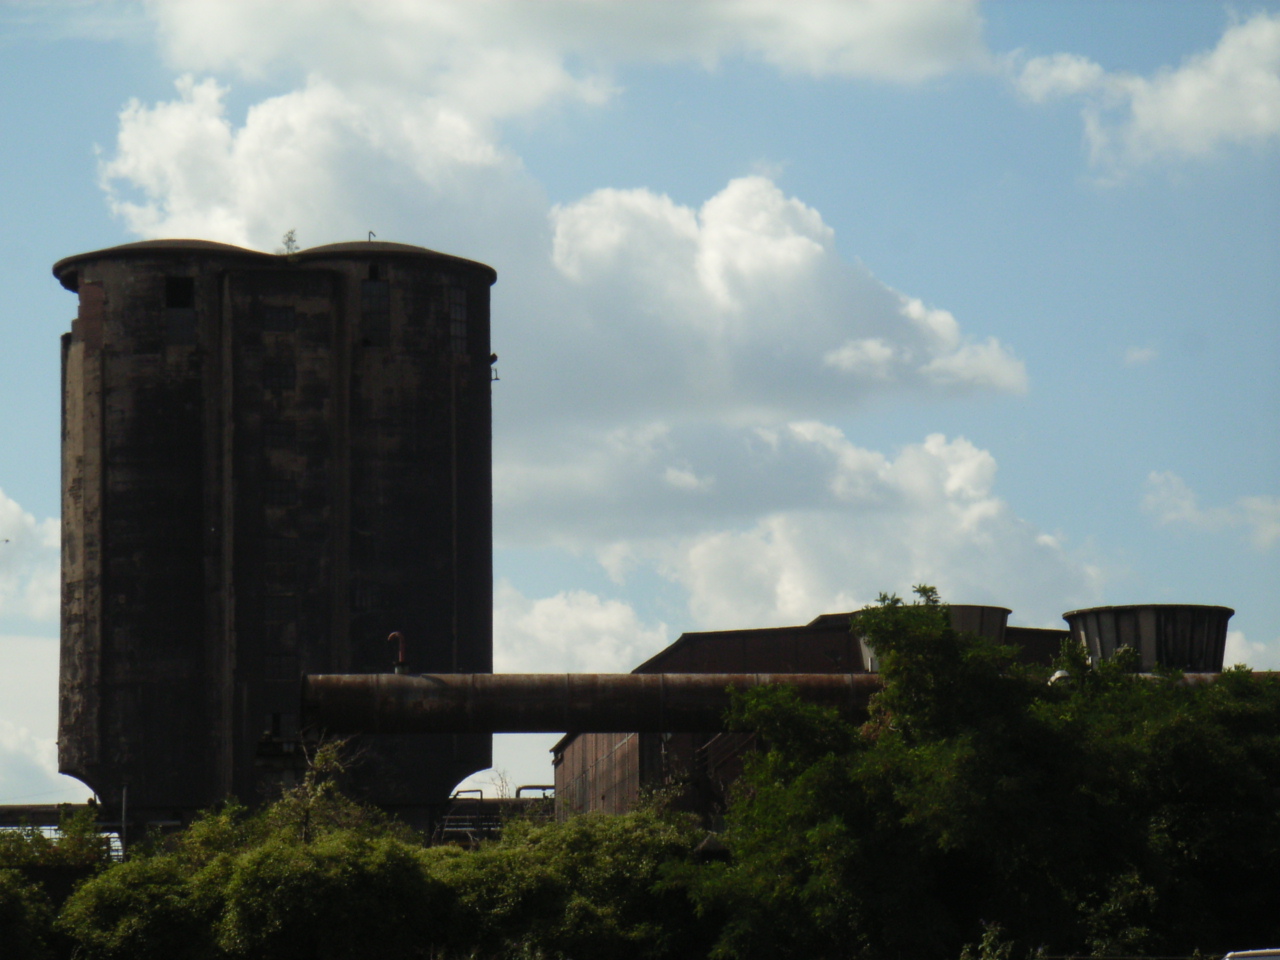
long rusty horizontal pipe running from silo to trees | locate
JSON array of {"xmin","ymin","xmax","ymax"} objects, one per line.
[{"xmin": 302, "ymin": 673, "xmax": 881, "ymax": 733}]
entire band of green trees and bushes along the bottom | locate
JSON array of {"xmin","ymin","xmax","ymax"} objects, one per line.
[{"xmin": 0, "ymin": 588, "xmax": 1280, "ymax": 960}]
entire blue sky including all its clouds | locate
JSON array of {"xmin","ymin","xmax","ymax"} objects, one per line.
[{"xmin": 0, "ymin": 0, "xmax": 1280, "ymax": 803}]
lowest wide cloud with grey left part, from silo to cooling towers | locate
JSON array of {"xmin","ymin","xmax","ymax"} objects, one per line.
[{"xmin": 495, "ymin": 420, "xmax": 1101, "ymax": 634}]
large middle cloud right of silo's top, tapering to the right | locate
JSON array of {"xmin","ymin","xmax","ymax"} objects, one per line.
[{"xmin": 550, "ymin": 175, "xmax": 1027, "ymax": 416}]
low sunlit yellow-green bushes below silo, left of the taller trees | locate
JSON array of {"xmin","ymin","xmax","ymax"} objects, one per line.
[{"xmin": 32, "ymin": 751, "xmax": 710, "ymax": 960}]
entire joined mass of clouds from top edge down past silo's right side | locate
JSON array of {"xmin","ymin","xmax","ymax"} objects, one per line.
[{"xmin": 90, "ymin": 0, "xmax": 1116, "ymax": 669}]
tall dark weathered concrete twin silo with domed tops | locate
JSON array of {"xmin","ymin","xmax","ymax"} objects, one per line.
[{"xmin": 54, "ymin": 241, "xmax": 495, "ymax": 822}]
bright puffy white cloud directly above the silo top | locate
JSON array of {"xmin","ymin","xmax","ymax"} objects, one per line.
[{"xmin": 100, "ymin": 76, "xmax": 513, "ymax": 247}]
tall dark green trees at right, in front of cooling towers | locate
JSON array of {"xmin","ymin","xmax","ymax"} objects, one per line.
[{"xmin": 699, "ymin": 588, "xmax": 1280, "ymax": 960}]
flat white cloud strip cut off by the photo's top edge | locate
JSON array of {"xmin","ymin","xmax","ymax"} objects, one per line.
[{"xmin": 147, "ymin": 0, "xmax": 988, "ymax": 89}]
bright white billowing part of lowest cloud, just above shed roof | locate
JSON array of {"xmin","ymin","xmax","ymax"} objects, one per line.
[{"xmin": 663, "ymin": 422, "xmax": 1098, "ymax": 628}]
